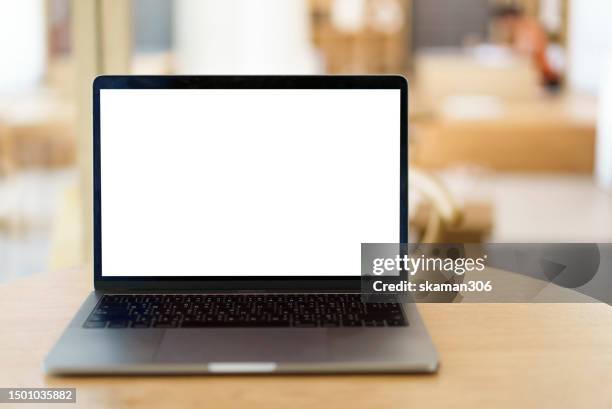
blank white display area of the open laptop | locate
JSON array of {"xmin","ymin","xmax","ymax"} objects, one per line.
[{"xmin": 100, "ymin": 89, "xmax": 401, "ymax": 277}]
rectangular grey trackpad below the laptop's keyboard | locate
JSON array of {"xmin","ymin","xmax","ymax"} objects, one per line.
[{"xmin": 156, "ymin": 328, "xmax": 329, "ymax": 363}]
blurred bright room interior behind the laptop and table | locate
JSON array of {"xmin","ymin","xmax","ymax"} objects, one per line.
[{"xmin": 0, "ymin": 0, "xmax": 612, "ymax": 281}]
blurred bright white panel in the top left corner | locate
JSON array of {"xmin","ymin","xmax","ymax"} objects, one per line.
[{"xmin": 0, "ymin": 0, "xmax": 47, "ymax": 91}]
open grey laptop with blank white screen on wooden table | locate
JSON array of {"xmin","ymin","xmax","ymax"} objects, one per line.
[{"xmin": 45, "ymin": 76, "xmax": 438, "ymax": 374}]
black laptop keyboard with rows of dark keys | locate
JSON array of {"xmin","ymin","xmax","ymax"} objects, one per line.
[{"xmin": 84, "ymin": 294, "xmax": 408, "ymax": 328}]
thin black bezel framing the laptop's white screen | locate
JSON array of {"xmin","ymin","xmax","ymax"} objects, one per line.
[{"xmin": 93, "ymin": 75, "xmax": 408, "ymax": 291}]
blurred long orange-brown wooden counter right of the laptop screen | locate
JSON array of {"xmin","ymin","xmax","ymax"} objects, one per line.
[{"xmin": 411, "ymin": 95, "xmax": 595, "ymax": 173}]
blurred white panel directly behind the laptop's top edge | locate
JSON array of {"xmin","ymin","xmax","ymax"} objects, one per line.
[{"xmin": 174, "ymin": 0, "xmax": 316, "ymax": 74}]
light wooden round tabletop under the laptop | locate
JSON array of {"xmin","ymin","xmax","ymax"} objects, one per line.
[{"xmin": 0, "ymin": 270, "xmax": 612, "ymax": 409}]
